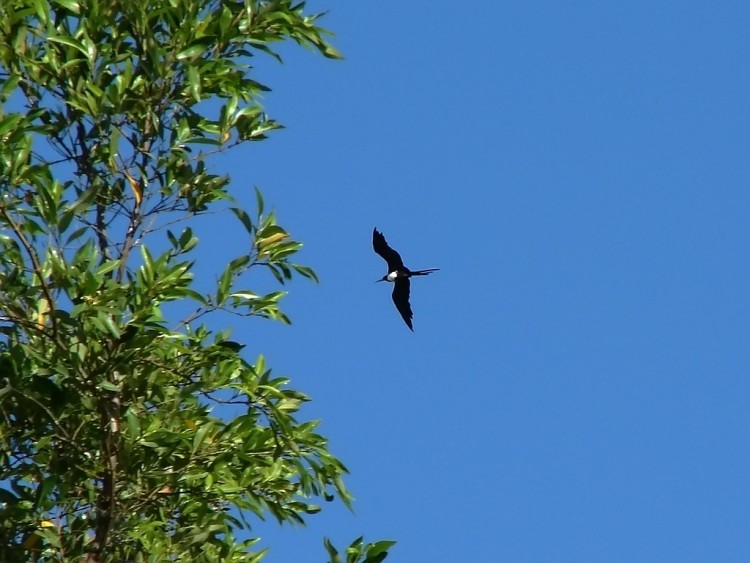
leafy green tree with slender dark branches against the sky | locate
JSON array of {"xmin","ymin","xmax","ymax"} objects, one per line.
[{"xmin": 0, "ymin": 0, "xmax": 392, "ymax": 563}]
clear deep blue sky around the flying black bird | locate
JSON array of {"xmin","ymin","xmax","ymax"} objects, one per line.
[{"xmin": 192, "ymin": 0, "xmax": 750, "ymax": 563}]
